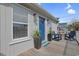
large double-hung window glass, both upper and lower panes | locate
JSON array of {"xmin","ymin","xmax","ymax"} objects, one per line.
[{"xmin": 13, "ymin": 5, "xmax": 28, "ymax": 39}]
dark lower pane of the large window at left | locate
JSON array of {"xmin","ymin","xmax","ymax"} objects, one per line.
[{"xmin": 13, "ymin": 23, "xmax": 27, "ymax": 39}]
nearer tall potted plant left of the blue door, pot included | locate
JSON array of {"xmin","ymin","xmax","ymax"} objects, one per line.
[{"xmin": 33, "ymin": 30, "xmax": 41, "ymax": 49}]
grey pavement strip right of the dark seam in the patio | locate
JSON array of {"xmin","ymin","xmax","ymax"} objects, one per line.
[{"xmin": 64, "ymin": 41, "xmax": 79, "ymax": 56}]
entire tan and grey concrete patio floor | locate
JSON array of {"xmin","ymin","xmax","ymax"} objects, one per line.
[{"xmin": 19, "ymin": 40, "xmax": 79, "ymax": 56}]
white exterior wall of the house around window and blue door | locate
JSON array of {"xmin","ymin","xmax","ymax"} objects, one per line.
[{"xmin": 0, "ymin": 4, "xmax": 56, "ymax": 56}]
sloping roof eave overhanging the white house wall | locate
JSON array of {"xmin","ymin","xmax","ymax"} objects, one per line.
[{"xmin": 20, "ymin": 3, "xmax": 58, "ymax": 23}]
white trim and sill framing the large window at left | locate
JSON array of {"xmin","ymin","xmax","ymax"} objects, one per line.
[{"xmin": 10, "ymin": 4, "xmax": 31, "ymax": 45}]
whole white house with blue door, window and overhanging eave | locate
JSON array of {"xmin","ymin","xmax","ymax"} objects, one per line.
[{"xmin": 0, "ymin": 3, "xmax": 58, "ymax": 55}]
